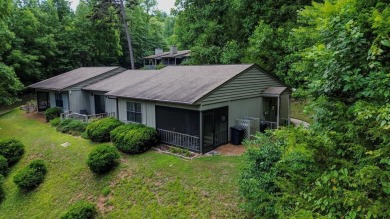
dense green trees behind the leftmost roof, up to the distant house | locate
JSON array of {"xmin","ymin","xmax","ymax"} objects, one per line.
[{"xmin": 0, "ymin": 0, "xmax": 173, "ymax": 104}]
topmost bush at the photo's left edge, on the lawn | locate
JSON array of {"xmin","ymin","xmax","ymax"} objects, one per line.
[{"xmin": 0, "ymin": 138, "xmax": 24, "ymax": 166}]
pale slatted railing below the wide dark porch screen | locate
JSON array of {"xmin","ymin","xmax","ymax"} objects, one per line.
[{"xmin": 157, "ymin": 129, "xmax": 200, "ymax": 152}]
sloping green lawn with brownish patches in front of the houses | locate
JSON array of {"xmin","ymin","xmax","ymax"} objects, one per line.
[{"xmin": 0, "ymin": 110, "xmax": 244, "ymax": 219}]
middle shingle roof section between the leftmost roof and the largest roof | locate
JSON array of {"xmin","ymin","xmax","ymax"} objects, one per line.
[{"xmin": 83, "ymin": 70, "xmax": 160, "ymax": 92}]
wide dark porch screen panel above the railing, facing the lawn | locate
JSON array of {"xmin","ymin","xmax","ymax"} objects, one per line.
[{"xmin": 156, "ymin": 106, "xmax": 200, "ymax": 136}]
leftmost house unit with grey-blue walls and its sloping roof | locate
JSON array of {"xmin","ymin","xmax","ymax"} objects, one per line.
[{"xmin": 28, "ymin": 67, "xmax": 126, "ymax": 114}]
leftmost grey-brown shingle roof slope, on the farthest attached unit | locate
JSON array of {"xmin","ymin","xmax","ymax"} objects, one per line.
[{"xmin": 28, "ymin": 66, "xmax": 120, "ymax": 91}]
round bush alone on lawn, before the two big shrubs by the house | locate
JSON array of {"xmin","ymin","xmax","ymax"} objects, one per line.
[{"xmin": 87, "ymin": 144, "xmax": 119, "ymax": 174}]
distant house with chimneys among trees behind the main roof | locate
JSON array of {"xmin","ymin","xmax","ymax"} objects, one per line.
[{"xmin": 143, "ymin": 46, "xmax": 191, "ymax": 69}]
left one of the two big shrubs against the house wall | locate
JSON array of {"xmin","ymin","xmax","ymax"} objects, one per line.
[{"xmin": 86, "ymin": 117, "xmax": 123, "ymax": 142}]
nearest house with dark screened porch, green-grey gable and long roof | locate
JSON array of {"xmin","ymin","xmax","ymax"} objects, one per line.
[{"xmin": 84, "ymin": 64, "xmax": 291, "ymax": 153}]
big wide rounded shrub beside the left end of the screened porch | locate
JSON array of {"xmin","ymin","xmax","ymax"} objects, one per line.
[{"xmin": 111, "ymin": 124, "xmax": 157, "ymax": 154}]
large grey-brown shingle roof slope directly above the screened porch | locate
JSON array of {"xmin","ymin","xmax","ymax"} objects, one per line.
[{"xmin": 106, "ymin": 64, "xmax": 255, "ymax": 104}]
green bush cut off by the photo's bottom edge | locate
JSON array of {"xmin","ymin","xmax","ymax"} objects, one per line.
[{"xmin": 61, "ymin": 201, "xmax": 97, "ymax": 219}]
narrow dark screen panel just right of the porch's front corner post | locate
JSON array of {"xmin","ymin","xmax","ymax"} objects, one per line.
[{"xmin": 203, "ymin": 112, "xmax": 215, "ymax": 151}]
